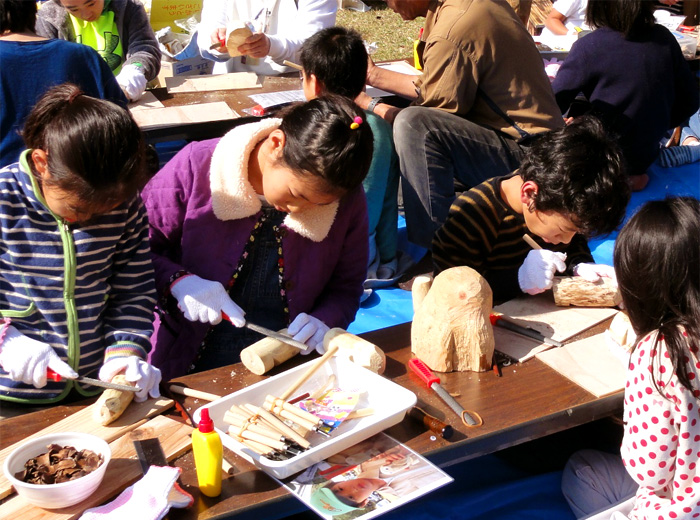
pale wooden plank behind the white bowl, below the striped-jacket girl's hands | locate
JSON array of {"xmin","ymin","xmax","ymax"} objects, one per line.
[{"xmin": 0, "ymin": 398, "xmax": 174, "ymax": 500}]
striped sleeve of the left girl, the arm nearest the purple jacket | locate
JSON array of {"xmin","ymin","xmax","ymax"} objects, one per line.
[{"xmin": 103, "ymin": 197, "xmax": 156, "ymax": 359}]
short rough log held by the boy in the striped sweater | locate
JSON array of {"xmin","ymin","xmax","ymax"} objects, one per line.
[{"xmin": 552, "ymin": 276, "xmax": 622, "ymax": 307}]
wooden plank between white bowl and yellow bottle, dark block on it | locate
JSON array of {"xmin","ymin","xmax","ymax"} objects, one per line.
[{"xmin": 0, "ymin": 415, "xmax": 192, "ymax": 520}]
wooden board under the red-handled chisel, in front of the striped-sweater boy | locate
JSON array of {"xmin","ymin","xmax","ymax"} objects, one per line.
[{"xmin": 493, "ymin": 292, "xmax": 619, "ymax": 361}]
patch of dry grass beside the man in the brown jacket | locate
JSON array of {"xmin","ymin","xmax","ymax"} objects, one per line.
[{"xmin": 336, "ymin": 0, "xmax": 425, "ymax": 61}]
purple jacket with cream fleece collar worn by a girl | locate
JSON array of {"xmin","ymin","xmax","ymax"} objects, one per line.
[{"xmin": 142, "ymin": 119, "xmax": 368, "ymax": 381}]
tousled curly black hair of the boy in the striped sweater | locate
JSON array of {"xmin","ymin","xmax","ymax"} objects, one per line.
[{"xmin": 519, "ymin": 115, "xmax": 630, "ymax": 237}]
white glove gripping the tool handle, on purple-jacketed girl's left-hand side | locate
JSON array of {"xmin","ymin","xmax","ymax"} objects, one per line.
[{"xmin": 170, "ymin": 274, "xmax": 245, "ymax": 327}]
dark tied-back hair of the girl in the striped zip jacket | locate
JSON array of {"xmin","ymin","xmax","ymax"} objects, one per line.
[{"xmin": 22, "ymin": 83, "xmax": 149, "ymax": 208}]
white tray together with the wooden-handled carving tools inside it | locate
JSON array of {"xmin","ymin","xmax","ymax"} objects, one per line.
[{"xmin": 194, "ymin": 353, "xmax": 416, "ymax": 478}]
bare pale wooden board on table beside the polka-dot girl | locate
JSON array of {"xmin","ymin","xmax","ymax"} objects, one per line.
[{"xmin": 537, "ymin": 334, "xmax": 627, "ymax": 397}]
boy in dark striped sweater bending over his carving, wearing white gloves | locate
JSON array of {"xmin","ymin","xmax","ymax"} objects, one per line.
[{"xmin": 432, "ymin": 116, "xmax": 630, "ymax": 302}]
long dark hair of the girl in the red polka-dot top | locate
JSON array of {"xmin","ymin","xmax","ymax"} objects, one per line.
[{"xmin": 613, "ymin": 197, "xmax": 700, "ymax": 397}]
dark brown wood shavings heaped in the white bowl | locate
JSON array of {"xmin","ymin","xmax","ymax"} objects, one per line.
[{"xmin": 15, "ymin": 444, "xmax": 103, "ymax": 484}]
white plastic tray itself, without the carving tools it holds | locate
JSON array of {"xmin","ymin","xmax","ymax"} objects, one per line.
[{"xmin": 194, "ymin": 358, "xmax": 416, "ymax": 478}]
